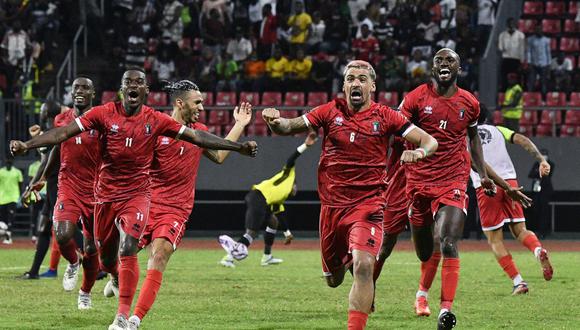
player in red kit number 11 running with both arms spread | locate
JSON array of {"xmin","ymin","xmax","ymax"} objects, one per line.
[{"xmin": 10, "ymin": 70, "xmax": 257, "ymax": 330}]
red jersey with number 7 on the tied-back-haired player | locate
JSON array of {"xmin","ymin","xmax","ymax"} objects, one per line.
[{"xmin": 150, "ymin": 123, "xmax": 207, "ymax": 221}]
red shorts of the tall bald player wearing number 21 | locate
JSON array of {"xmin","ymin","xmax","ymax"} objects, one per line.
[{"xmin": 407, "ymin": 182, "xmax": 469, "ymax": 227}]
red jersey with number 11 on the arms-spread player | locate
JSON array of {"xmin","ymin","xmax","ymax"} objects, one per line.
[{"xmin": 75, "ymin": 102, "xmax": 185, "ymax": 202}]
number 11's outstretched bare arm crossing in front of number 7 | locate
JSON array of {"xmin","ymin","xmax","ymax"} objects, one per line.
[{"xmin": 180, "ymin": 127, "xmax": 258, "ymax": 157}]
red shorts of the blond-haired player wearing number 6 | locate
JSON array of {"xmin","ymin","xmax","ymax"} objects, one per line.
[{"xmin": 319, "ymin": 196, "xmax": 385, "ymax": 276}]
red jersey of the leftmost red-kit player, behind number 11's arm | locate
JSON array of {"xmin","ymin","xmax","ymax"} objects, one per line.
[{"xmin": 54, "ymin": 109, "xmax": 101, "ymax": 201}]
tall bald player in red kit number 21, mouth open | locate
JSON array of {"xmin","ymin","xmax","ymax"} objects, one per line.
[{"xmin": 400, "ymin": 48, "xmax": 494, "ymax": 329}]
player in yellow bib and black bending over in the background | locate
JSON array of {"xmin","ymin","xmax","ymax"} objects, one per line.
[{"xmin": 218, "ymin": 132, "xmax": 316, "ymax": 268}]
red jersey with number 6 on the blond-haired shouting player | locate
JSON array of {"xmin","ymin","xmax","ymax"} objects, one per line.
[{"xmin": 303, "ymin": 99, "xmax": 411, "ymax": 207}]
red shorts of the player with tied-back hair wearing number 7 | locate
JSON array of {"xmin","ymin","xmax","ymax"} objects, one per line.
[{"xmin": 139, "ymin": 209, "xmax": 188, "ymax": 250}]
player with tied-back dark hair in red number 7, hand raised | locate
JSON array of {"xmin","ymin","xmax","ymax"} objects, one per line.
[{"xmin": 129, "ymin": 80, "xmax": 252, "ymax": 329}]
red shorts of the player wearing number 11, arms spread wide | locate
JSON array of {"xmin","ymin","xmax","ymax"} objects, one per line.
[{"xmin": 95, "ymin": 196, "xmax": 150, "ymax": 249}]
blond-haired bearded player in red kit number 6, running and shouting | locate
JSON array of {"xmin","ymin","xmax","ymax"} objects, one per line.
[{"xmin": 262, "ymin": 61, "xmax": 437, "ymax": 329}]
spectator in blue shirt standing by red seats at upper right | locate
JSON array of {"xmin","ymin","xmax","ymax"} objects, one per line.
[{"xmin": 526, "ymin": 22, "xmax": 552, "ymax": 95}]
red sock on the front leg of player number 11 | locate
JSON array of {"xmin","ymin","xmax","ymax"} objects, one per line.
[{"xmin": 117, "ymin": 255, "xmax": 139, "ymax": 318}]
